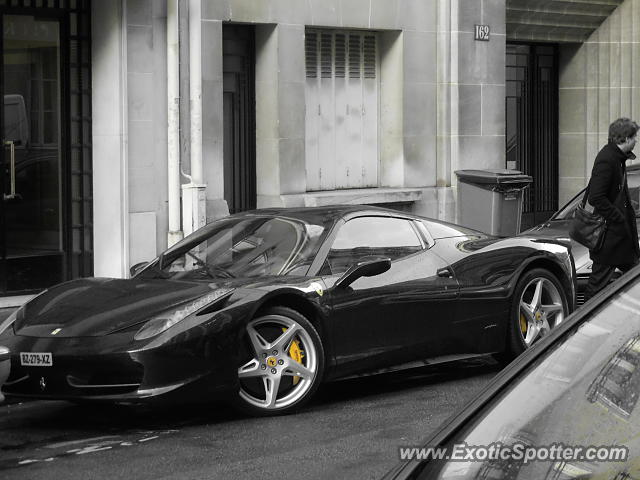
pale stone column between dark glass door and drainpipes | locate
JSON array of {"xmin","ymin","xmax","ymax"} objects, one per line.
[{"xmin": 91, "ymin": 1, "xmax": 129, "ymax": 278}]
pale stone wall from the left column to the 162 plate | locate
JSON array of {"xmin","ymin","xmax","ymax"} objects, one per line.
[{"xmin": 93, "ymin": 0, "xmax": 505, "ymax": 276}]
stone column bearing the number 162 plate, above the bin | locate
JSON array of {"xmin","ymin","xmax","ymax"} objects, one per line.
[{"xmin": 437, "ymin": 0, "xmax": 506, "ymax": 220}]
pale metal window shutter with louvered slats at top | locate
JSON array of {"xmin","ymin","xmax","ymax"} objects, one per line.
[{"xmin": 305, "ymin": 29, "xmax": 379, "ymax": 191}]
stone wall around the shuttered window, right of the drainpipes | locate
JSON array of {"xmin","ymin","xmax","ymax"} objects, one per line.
[{"xmin": 203, "ymin": 0, "xmax": 506, "ymax": 220}]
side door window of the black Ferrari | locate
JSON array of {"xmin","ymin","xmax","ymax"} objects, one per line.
[{"xmin": 321, "ymin": 217, "xmax": 423, "ymax": 274}]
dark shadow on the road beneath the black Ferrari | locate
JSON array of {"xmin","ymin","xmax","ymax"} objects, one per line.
[{"xmin": 0, "ymin": 357, "xmax": 501, "ymax": 438}]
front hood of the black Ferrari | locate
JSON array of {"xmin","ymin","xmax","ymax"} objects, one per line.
[{"xmin": 15, "ymin": 278, "xmax": 230, "ymax": 338}]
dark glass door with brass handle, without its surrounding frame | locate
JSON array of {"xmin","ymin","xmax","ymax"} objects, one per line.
[{"xmin": 0, "ymin": 15, "xmax": 64, "ymax": 291}]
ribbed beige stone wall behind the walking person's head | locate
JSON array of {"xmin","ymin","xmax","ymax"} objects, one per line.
[{"xmin": 559, "ymin": 0, "xmax": 640, "ymax": 205}]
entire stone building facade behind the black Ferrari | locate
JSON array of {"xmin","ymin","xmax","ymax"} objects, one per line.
[{"xmin": 0, "ymin": 0, "xmax": 640, "ymax": 302}]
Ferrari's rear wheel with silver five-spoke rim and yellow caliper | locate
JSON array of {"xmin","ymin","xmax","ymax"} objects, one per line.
[{"xmin": 508, "ymin": 268, "xmax": 569, "ymax": 357}]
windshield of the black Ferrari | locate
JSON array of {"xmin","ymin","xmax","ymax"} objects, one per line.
[{"xmin": 139, "ymin": 216, "xmax": 329, "ymax": 279}]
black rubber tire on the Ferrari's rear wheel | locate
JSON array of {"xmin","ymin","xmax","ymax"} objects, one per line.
[{"xmin": 502, "ymin": 268, "xmax": 569, "ymax": 362}]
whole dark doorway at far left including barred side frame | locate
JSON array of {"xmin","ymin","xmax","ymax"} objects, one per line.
[{"xmin": 0, "ymin": 0, "xmax": 93, "ymax": 295}]
